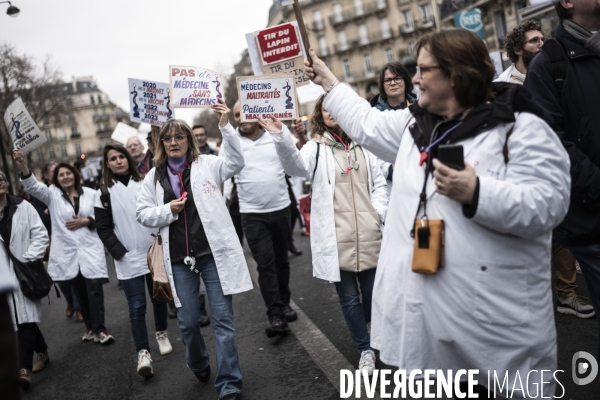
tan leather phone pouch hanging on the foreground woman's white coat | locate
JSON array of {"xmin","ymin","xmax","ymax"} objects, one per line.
[{"xmin": 412, "ymin": 218, "xmax": 444, "ymax": 275}]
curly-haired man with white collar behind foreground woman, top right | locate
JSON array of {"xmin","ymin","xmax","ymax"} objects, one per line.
[{"xmin": 494, "ymin": 20, "xmax": 544, "ymax": 85}]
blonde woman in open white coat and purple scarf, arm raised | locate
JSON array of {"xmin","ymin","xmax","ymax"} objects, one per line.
[{"xmin": 137, "ymin": 100, "xmax": 252, "ymax": 400}]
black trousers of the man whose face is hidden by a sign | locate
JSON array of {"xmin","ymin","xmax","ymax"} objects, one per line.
[{"xmin": 242, "ymin": 207, "xmax": 291, "ymax": 320}]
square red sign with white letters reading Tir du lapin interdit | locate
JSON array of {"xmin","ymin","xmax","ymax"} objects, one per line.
[{"xmin": 256, "ymin": 23, "xmax": 302, "ymax": 65}]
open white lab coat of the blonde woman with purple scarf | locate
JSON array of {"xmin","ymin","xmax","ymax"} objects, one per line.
[{"xmin": 136, "ymin": 124, "xmax": 252, "ymax": 307}]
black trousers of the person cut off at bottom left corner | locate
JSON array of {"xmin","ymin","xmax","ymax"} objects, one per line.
[{"xmin": 0, "ymin": 292, "xmax": 19, "ymax": 400}]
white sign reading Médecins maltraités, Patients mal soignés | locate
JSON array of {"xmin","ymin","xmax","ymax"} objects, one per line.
[{"xmin": 236, "ymin": 75, "xmax": 298, "ymax": 122}]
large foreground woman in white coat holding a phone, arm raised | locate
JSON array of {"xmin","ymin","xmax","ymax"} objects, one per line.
[{"xmin": 306, "ymin": 29, "xmax": 570, "ymax": 396}]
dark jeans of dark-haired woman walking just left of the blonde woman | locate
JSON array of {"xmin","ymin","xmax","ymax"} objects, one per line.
[{"xmin": 121, "ymin": 273, "xmax": 167, "ymax": 352}]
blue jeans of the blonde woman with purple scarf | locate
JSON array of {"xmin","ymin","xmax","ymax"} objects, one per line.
[{"xmin": 171, "ymin": 254, "xmax": 242, "ymax": 398}]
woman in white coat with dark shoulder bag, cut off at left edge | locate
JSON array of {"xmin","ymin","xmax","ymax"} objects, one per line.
[{"xmin": 0, "ymin": 172, "xmax": 50, "ymax": 389}]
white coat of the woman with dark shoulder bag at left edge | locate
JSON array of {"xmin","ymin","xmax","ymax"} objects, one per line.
[{"xmin": 0, "ymin": 198, "xmax": 48, "ymax": 331}]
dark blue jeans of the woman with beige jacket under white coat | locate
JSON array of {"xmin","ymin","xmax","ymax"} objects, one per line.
[{"xmin": 335, "ymin": 268, "xmax": 376, "ymax": 352}]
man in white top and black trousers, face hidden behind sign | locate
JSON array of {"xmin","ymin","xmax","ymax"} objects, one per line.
[{"xmin": 233, "ymin": 102, "xmax": 298, "ymax": 337}]
